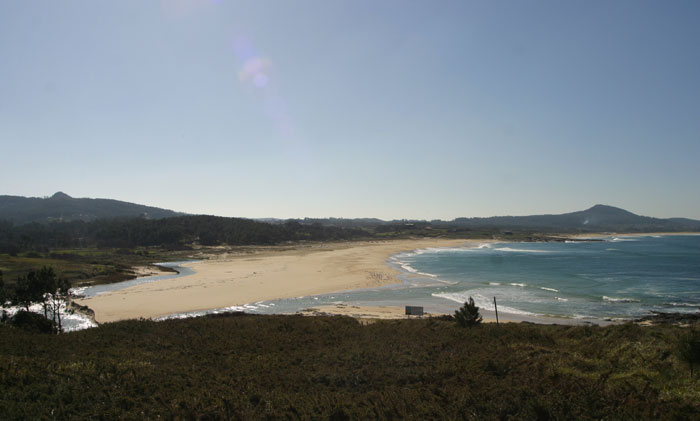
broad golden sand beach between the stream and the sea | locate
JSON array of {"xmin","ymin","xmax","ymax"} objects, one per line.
[{"xmin": 75, "ymin": 239, "xmax": 484, "ymax": 323}]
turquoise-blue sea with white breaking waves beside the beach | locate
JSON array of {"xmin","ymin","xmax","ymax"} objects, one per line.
[{"xmin": 241, "ymin": 236, "xmax": 700, "ymax": 319}]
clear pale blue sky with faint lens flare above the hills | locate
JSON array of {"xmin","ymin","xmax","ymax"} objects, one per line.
[{"xmin": 0, "ymin": 0, "xmax": 700, "ymax": 219}]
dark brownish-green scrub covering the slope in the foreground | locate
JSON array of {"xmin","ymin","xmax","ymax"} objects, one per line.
[{"xmin": 0, "ymin": 315, "xmax": 700, "ymax": 419}]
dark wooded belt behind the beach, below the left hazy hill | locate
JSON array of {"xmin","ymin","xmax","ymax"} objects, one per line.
[{"xmin": 0, "ymin": 215, "xmax": 370, "ymax": 254}]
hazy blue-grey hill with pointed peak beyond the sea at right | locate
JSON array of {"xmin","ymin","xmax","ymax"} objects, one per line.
[{"xmin": 447, "ymin": 205, "xmax": 700, "ymax": 232}]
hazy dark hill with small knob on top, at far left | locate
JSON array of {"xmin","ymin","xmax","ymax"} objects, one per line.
[{"xmin": 0, "ymin": 192, "xmax": 184, "ymax": 225}]
